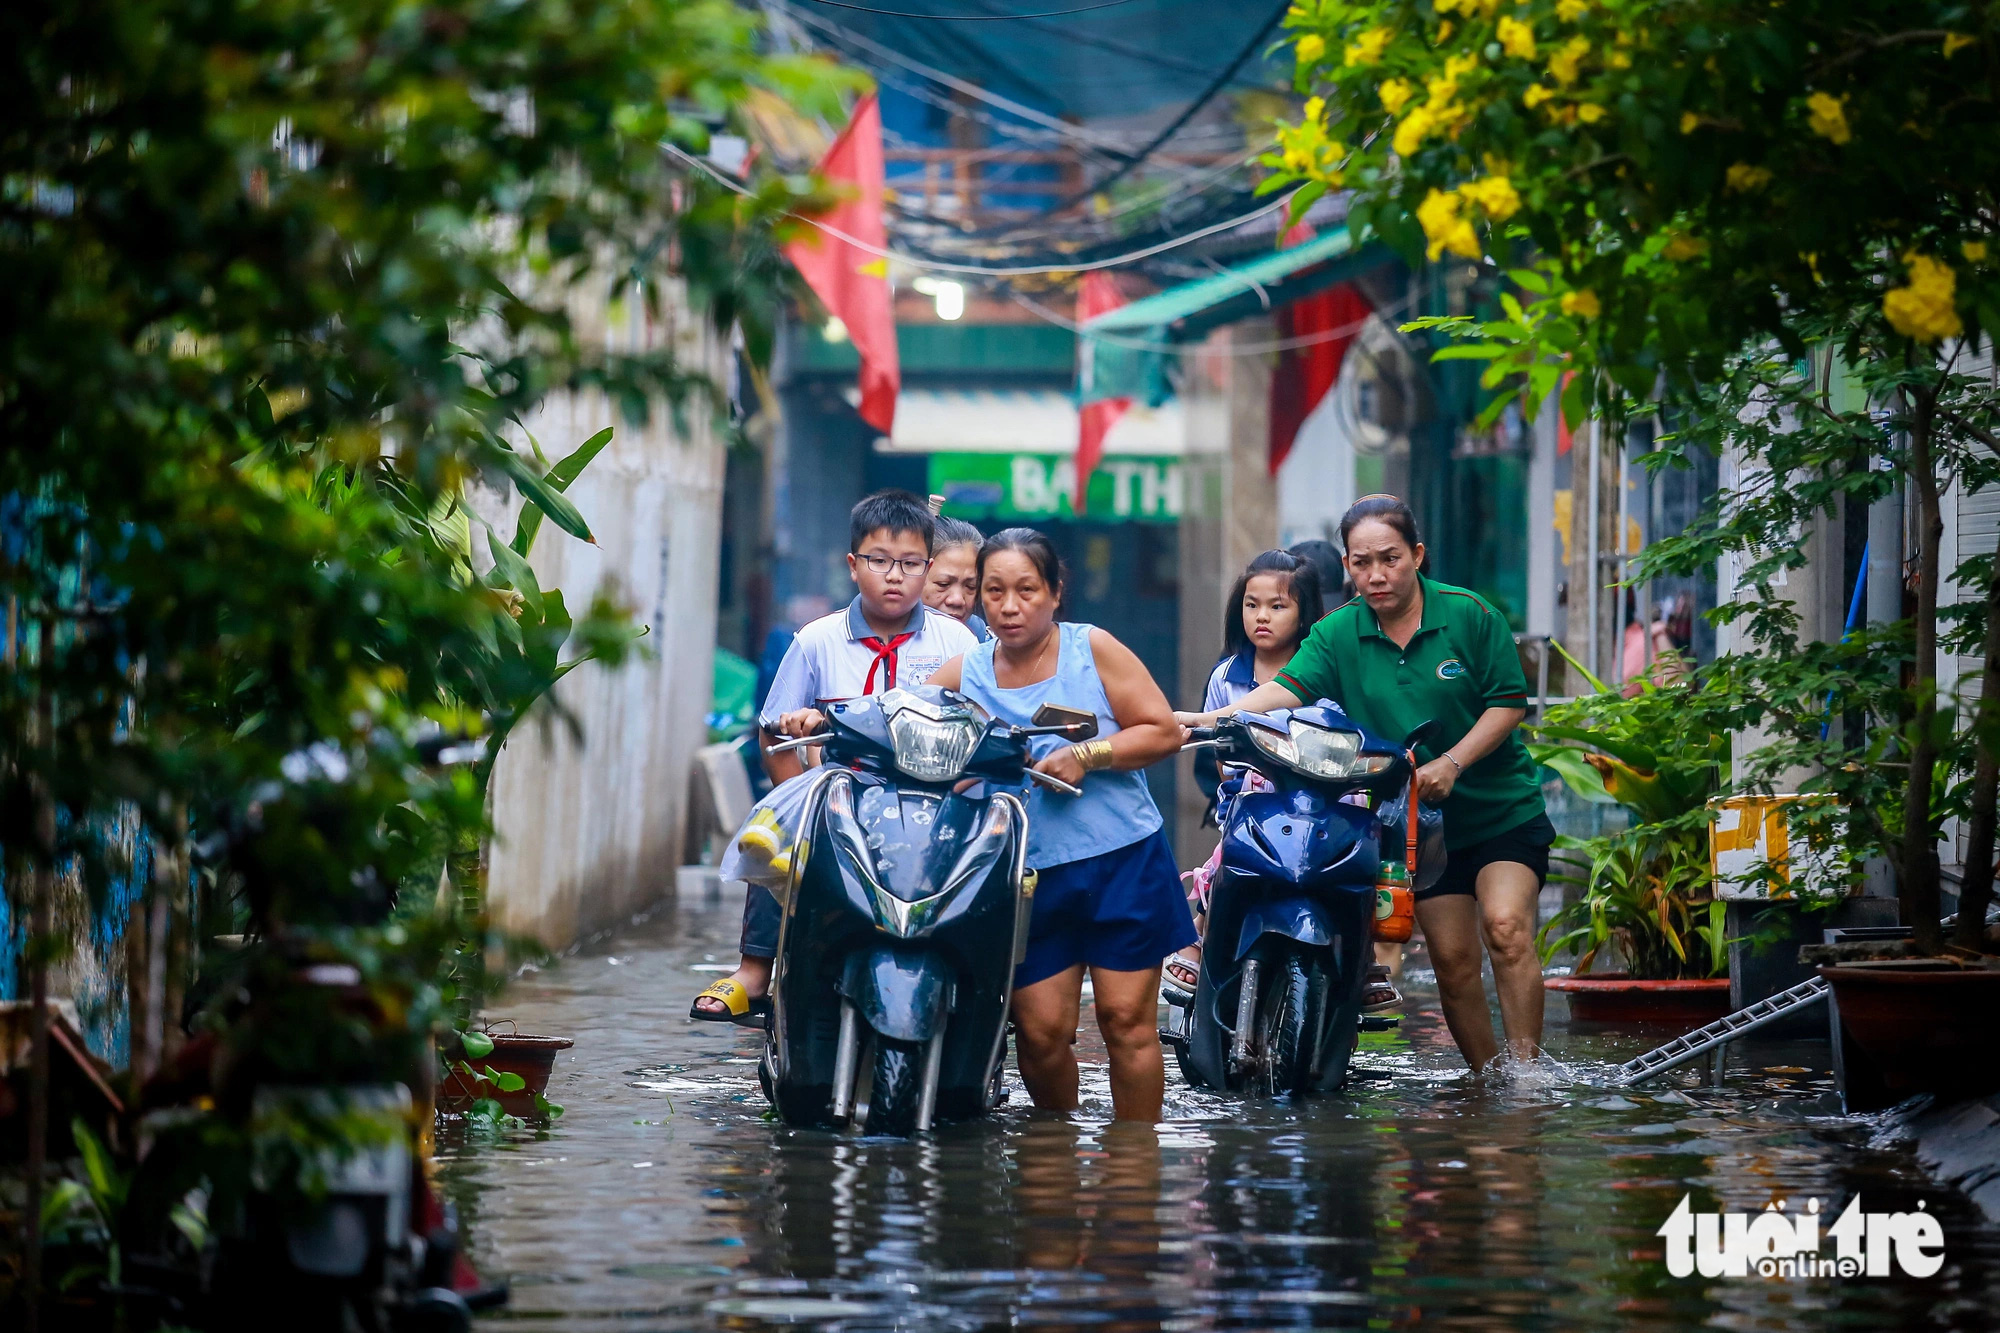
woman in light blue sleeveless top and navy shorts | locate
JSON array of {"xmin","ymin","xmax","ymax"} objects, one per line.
[{"xmin": 930, "ymin": 528, "xmax": 1194, "ymax": 1121}]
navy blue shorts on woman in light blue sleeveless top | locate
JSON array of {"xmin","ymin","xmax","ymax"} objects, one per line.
[{"xmin": 1014, "ymin": 829, "xmax": 1198, "ymax": 987}]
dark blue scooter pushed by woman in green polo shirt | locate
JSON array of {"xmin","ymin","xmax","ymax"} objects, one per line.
[{"xmin": 1160, "ymin": 699, "xmax": 1422, "ymax": 1095}]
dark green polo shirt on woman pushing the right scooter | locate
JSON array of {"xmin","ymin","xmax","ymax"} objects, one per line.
[{"xmin": 1278, "ymin": 578, "xmax": 1542, "ymax": 847}]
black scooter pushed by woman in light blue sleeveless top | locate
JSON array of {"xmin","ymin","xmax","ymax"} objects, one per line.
[{"xmin": 760, "ymin": 687, "xmax": 1098, "ymax": 1135}]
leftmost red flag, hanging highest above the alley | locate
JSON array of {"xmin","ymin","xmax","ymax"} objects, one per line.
[{"xmin": 784, "ymin": 92, "xmax": 902, "ymax": 434}]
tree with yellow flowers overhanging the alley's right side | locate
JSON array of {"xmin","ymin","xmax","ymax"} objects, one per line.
[{"xmin": 1266, "ymin": 0, "xmax": 2000, "ymax": 947}]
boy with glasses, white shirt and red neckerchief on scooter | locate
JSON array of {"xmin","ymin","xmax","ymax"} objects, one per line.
[{"xmin": 688, "ymin": 490, "xmax": 976, "ymax": 1025}]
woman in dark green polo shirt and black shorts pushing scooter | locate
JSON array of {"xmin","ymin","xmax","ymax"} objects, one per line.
[{"xmin": 1176, "ymin": 494, "xmax": 1556, "ymax": 1071}]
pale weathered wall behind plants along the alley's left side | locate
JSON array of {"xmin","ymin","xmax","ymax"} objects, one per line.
[{"xmin": 474, "ymin": 282, "xmax": 728, "ymax": 949}]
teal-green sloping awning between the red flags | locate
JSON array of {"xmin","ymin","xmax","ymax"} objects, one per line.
[{"xmin": 1078, "ymin": 226, "xmax": 1390, "ymax": 404}]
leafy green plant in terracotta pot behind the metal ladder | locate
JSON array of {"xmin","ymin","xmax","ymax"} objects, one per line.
[{"xmin": 1528, "ymin": 646, "xmax": 1730, "ymax": 1027}]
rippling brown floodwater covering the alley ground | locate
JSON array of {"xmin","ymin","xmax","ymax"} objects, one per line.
[{"xmin": 440, "ymin": 880, "xmax": 2000, "ymax": 1333}]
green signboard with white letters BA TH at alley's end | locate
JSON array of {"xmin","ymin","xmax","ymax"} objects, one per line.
[{"xmin": 930, "ymin": 454, "xmax": 1182, "ymax": 522}]
